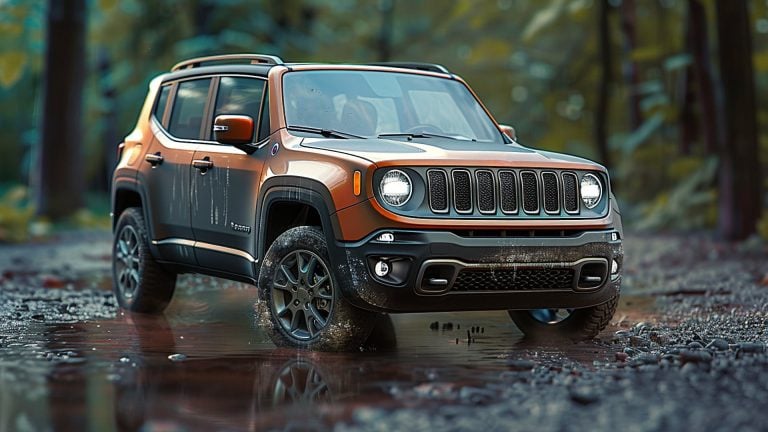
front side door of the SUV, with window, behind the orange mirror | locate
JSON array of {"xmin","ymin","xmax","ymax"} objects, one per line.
[{"xmin": 191, "ymin": 76, "xmax": 268, "ymax": 276}]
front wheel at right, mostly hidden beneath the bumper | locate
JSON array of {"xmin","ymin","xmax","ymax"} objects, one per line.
[{"xmin": 509, "ymin": 295, "xmax": 619, "ymax": 340}]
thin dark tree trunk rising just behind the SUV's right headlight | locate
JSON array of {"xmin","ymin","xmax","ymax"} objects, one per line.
[{"xmin": 594, "ymin": 0, "xmax": 612, "ymax": 166}]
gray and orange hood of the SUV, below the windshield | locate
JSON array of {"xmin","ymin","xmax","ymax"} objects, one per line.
[{"xmin": 301, "ymin": 138, "xmax": 604, "ymax": 170}]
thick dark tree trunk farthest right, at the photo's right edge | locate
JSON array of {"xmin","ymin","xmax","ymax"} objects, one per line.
[{"xmin": 716, "ymin": 0, "xmax": 762, "ymax": 240}]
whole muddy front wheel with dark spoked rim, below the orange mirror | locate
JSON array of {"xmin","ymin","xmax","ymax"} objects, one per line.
[{"xmin": 257, "ymin": 226, "xmax": 376, "ymax": 351}]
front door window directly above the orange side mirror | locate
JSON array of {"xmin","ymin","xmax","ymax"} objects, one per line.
[{"xmin": 208, "ymin": 77, "xmax": 264, "ymax": 138}]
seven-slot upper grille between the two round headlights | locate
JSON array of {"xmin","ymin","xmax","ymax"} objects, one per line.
[{"xmin": 427, "ymin": 168, "xmax": 579, "ymax": 215}]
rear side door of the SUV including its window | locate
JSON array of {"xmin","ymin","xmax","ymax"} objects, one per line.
[{"xmin": 141, "ymin": 78, "xmax": 211, "ymax": 264}]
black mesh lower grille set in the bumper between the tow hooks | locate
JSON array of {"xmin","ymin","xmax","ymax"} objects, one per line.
[{"xmin": 451, "ymin": 268, "xmax": 575, "ymax": 292}]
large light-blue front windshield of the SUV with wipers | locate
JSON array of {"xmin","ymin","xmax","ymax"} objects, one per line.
[{"xmin": 283, "ymin": 70, "xmax": 502, "ymax": 142}]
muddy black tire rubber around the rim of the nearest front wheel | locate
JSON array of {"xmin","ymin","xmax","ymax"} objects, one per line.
[{"xmin": 256, "ymin": 226, "xmax": 377, "ymax": 351}]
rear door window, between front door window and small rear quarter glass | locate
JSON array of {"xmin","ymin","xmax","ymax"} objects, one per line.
[{"xmin": 168, "ymin": 79, "xmax": 211, "ymax": 139}]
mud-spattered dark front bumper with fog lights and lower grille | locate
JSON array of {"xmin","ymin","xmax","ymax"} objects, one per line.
[{"xmin": 330, "ymin": 230, "xmax": 624, "ymax": 312}]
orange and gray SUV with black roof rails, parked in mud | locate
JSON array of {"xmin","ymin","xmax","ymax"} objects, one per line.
[{"xmin": 112, "ymin": 54, "xmax": 623, "ymax": 350}]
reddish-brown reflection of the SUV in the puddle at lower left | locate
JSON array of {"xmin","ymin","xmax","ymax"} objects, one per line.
[{"xmin": 113, "ymin": 315, "xmax": 396, "ymax": 431}]
